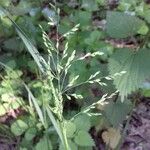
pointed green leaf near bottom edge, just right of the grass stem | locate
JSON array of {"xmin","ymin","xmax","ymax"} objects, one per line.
[{"xmin": 74, "ymin": 130, "xmax": 95, "ymax": 146}]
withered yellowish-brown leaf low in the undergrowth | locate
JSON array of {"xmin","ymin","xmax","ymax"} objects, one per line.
[{"xmin": 102, "ymin": 128, "xmax": 121, "ymax": 149}]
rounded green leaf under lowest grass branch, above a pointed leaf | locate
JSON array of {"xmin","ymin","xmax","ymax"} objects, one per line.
[{"xmin": 74, "ymin": 114, "xmax": 91, "ymax": 131}]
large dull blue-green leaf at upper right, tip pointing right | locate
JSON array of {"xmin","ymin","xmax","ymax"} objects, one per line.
[{"xmin": 106, "ymin": 11, "xmax": 145, "ymax": 38}]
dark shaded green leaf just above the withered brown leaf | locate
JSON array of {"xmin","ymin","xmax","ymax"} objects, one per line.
[{"xmin": 104, "ymin": 100, "xmax": 131, "ymax": 127}]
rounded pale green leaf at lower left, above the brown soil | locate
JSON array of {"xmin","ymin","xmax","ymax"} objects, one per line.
[{"xmin": 11, "ymin": 119, "xmax": 28, "ymax": 136}]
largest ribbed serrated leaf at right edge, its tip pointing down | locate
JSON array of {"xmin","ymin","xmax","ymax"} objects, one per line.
[{"xmin": 108, "ymin": 48, "xmax": 150, "ymax": 100}]
